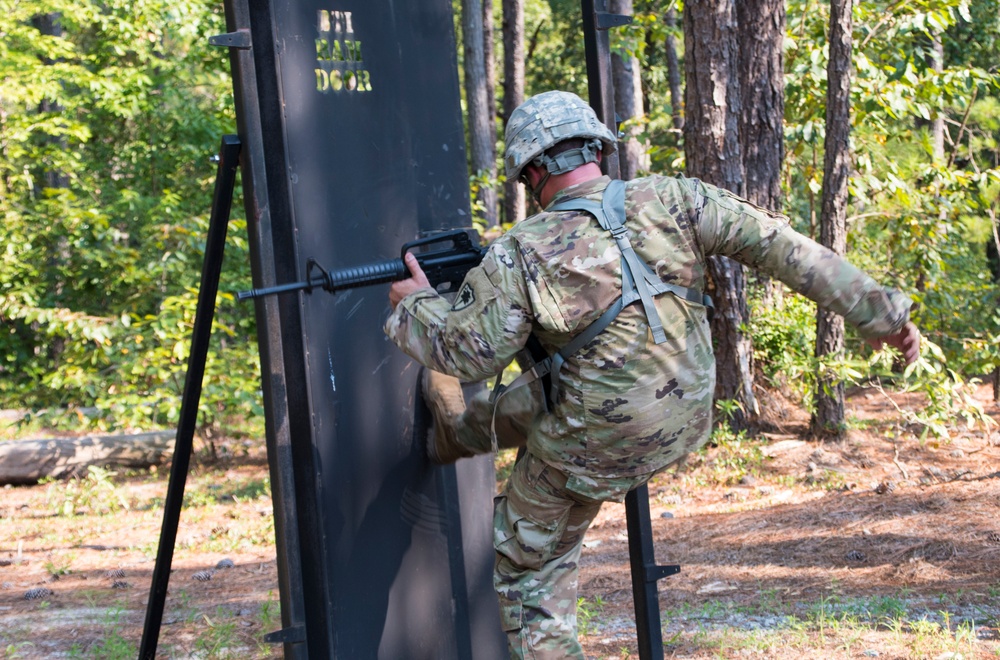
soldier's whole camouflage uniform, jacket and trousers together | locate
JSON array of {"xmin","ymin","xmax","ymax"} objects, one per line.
[{"xmin": 385, "ymin": 176, "xmax": 910, "ymax": 658}]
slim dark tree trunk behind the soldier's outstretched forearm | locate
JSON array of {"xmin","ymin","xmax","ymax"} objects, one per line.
[{"xmin": 811, "ymin": 0, "xmax": 852, "ymax": 437}]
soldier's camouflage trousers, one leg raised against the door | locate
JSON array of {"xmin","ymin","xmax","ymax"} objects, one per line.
[{"xmin": 456, "ymin": 385, "xmax": 602, "ymax": 660}]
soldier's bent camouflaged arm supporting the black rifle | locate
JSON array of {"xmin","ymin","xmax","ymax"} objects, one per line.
[{"xmin": 384, "ymin": 241, "xmax": 532, "ymax": 382}]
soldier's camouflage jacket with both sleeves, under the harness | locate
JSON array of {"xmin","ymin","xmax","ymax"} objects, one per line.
[{"xmin": 385, "ymin": 176, "xmax": 910, "ymax": 499}]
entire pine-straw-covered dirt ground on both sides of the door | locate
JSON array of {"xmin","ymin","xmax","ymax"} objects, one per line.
[{"xmin": 0, "ymin": 386, "xmax": 1000, "ymax": 660}]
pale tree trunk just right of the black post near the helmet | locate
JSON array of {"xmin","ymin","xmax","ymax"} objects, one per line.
[{"xmin": 609, "ymin": 0, "xmax": 649, "ymax": 181}]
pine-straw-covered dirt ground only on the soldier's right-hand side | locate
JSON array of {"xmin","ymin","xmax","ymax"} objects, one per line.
[{"xmin": 581, "ymin": 378, "xmax": 1000, "ymax": 660}]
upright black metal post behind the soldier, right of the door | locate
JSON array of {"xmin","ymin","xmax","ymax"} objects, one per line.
[{"xmin": 580, "ymin": 0, "xmax": 681, "ymax": 660}]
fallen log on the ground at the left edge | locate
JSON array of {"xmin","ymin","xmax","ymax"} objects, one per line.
[{"xmin": 0, "ymin": 431, "xmax": 177, "ymax": 484}]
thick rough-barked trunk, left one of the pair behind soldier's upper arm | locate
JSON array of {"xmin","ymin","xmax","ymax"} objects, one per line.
[{"xmin": 683, "ymin": 0, "xmax": 757, "ymax": 431}]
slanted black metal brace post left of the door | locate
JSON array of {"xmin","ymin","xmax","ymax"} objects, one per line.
[{"xmin": 139, "ymin": 135, "xmax": 241, "ymax": 660}]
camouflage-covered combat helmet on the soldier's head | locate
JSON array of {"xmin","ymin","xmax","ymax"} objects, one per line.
[{"xmin": 504, "ymin": 91, "xmax": 615, "ymax": 181}]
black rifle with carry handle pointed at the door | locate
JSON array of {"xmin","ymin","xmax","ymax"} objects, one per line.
[{"xmin": 236, "ymin": 229, "xmax": 486, "ymax": 300}]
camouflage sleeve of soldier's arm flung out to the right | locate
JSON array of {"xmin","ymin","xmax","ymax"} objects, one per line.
[{"xmin": 698, "ymin": 184, "xmax": 915, "ymax": 346}]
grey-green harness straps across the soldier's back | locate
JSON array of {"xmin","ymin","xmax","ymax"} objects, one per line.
[{"xmin": 490, "ymin": 179, "xmax": 714, "ymax": 452}]
